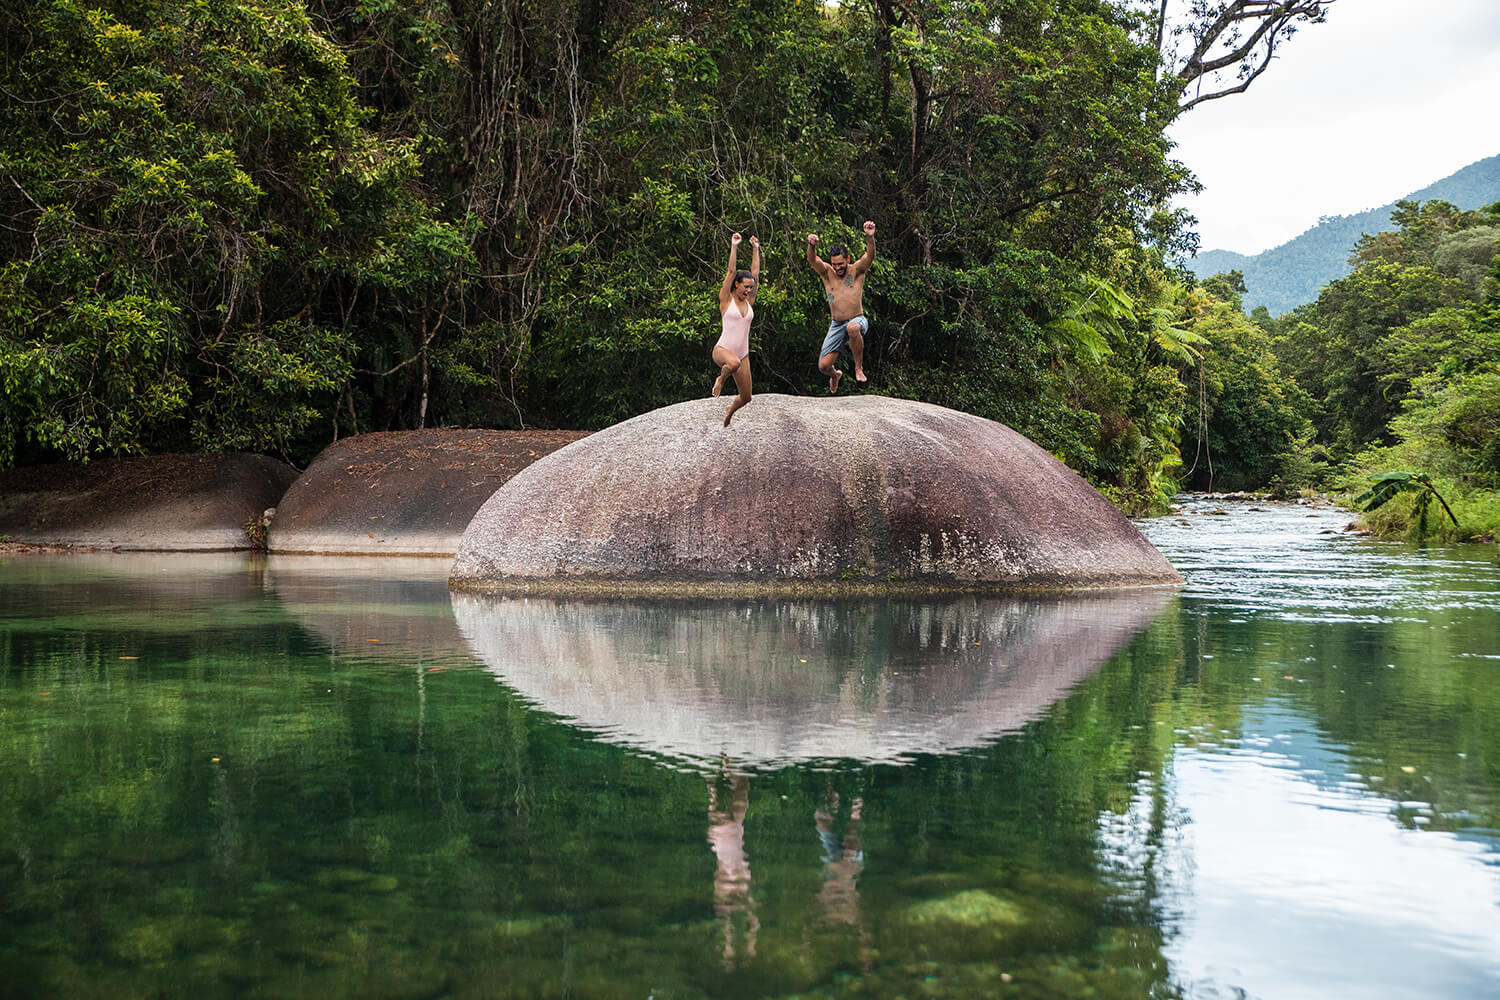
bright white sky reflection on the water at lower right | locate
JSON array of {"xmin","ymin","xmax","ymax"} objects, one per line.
[{"xmin": 1101, "ymin": 702, "xmax": 1500, "ymax": 1000}]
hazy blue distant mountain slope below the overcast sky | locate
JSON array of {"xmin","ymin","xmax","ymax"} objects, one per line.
[{"xmin": 1188, "ymin": 154, "xmax": 1500, "ymax": 316}]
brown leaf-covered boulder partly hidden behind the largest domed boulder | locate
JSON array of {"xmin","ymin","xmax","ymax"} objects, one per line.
[{"xmin": 269, "ymin": 429, "xmax": 588, "ymax": 556}]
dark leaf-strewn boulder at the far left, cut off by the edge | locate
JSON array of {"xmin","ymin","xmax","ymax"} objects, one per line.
[{"xmin": 0, "ymin": 454, "xmax": 297, "ymax": 552}]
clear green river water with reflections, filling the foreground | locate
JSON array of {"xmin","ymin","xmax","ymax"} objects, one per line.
[{"xmin": 0, "ymin": 501, "xmax": 1500, "ymax": 1000}]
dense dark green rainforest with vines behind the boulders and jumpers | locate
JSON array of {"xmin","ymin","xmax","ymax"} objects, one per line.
[{"xmin": 0, "ymin": 0, "xmax": 1362, "ymax": 505}]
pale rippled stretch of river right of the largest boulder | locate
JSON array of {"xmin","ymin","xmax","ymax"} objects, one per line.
[{"xmin": 1140, "ymin": 498, "xmax": 1500, "ymax": 622}]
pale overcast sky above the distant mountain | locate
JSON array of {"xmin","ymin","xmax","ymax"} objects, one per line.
[{"xmin": 1172, "ymin": 0, "xmax": 1500, "ymax": 253}]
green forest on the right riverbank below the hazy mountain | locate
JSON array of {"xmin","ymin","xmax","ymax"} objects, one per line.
[{"xmin": 1184, "ymin": 199, "xmax": 1500, "ymax": 538}]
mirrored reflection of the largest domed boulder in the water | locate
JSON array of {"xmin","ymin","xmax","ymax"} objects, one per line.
[{"xmin": 453, "ymin": 589, "xmax": 1172, "ymax": 768}]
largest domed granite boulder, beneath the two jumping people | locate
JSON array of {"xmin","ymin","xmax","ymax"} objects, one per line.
[{"xmin": 450, "ymin": 394, "xmax": 1181, "ymax": 592}]
